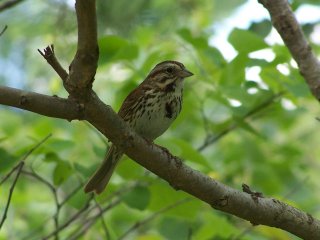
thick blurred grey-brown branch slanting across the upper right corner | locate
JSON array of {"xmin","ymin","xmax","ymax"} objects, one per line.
[{"xmin": 258, "ymin": 0, "xmax": 320, "ymax": 101}]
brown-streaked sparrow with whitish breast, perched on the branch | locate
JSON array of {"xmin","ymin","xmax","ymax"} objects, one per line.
[{"xmin": 84, "ymin": 61, "xmax": 193, "ymax": 194}]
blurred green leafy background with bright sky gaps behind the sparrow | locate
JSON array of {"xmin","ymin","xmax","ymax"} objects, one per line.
[{"xmin": 0, "ymin": 0, "xmax": 320, "ymax": 240}]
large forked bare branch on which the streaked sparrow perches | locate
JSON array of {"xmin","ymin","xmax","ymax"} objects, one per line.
[{"xmin": 0, "ymin": 0, "xmax": 320, "ymax": 239}]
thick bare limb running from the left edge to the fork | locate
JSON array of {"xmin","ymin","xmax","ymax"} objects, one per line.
[{"xmin": 0, "ymin": 86, "xmax": 83, "ymax": 121}]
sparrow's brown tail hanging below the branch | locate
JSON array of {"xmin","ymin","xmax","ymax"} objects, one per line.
[{"xmin": 84, "ymin": 145, "xmax": 123, "ymax": 194}]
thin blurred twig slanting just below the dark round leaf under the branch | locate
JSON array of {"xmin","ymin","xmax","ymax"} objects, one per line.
[{"xmin": 119, "ymin": 198, "xmax": 191, "ymax": 240}]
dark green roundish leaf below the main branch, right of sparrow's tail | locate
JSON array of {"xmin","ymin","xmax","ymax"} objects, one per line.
[{"xmin": 123, "ymin": 186, "xmax": 150, "ymax": 211}]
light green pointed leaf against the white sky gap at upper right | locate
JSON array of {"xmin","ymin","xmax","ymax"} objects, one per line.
[{"xmin": 228, "ymin": 28, "xmax": 269, "ymax": 53}]
